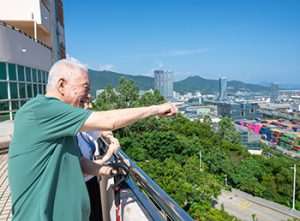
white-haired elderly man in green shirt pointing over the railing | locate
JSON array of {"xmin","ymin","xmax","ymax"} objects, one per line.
[{"xmin": 8, "ymin": 60, "xmax": 180, "ymax": 221}]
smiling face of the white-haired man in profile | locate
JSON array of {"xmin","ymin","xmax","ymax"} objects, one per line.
[{"xmin": 64, "ymin": 71, "xmax": 91, "ymax": 107}]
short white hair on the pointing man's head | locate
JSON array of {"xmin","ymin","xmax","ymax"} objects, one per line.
[{"xmin": 47, "ymin": 59, "xmax": 88, "ymax": 91}]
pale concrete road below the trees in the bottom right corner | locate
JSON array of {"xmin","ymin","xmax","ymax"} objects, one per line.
[{"xmin": 215, "ymin": 190, "xmax": 300, "ymax": 221}]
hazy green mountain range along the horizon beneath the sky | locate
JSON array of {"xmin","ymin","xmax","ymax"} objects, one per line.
[{"xmin": 88, "ymin": 70, "xmax": 270, "ymax": 95}]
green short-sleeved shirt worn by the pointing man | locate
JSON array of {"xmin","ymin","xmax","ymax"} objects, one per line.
[{"xmin": 8, "ymin": 95, "xmax": 91, "ymax": 221}]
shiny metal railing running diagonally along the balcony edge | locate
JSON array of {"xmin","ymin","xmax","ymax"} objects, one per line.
[{"xmin": 116, "ymin": 150, "xmax": 193, "ymax": 221}]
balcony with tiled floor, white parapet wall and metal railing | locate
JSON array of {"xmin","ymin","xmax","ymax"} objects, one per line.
[{"xmin": 0, "ymin": 129, "xmax": 193, "ymax": 221}]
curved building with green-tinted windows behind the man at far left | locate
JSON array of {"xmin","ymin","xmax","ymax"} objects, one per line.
[{"xmin": 0, "ymin": 0, "xmax": 65, "ymax": 121}]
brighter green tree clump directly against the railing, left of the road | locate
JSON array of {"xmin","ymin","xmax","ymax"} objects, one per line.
[{"xmin": 139, "ymin": 156, "xmax": 221, "ymax": 218}]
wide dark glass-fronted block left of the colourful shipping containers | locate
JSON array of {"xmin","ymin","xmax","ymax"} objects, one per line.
[{"xmin": 218, "ymin": 102, "xmax": 261, "ymax": 119}]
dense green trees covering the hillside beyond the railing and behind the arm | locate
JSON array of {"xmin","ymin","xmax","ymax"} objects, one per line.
[{"xmin": 94, "ymin": 78, "xmax": 300, "ymax": 218}]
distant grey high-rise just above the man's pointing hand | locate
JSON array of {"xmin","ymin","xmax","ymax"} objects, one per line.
[{"xmin": 154, "ymin": 70, "xmax": 173, "ymax": 98}]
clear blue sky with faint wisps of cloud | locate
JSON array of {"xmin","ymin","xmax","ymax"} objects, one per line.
[{"xmin": 63, "ymin": 0, "xmax": 300, "ymax": 84}]
